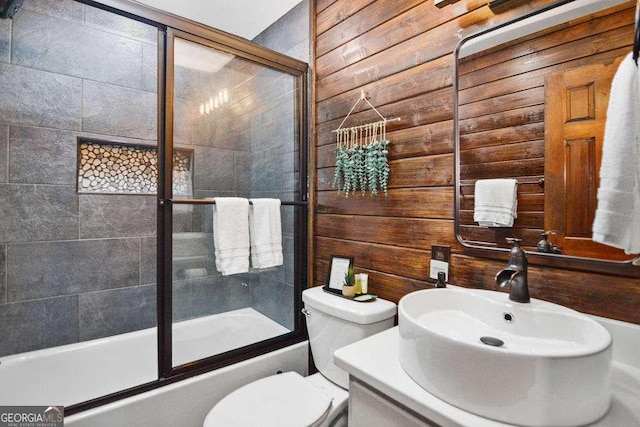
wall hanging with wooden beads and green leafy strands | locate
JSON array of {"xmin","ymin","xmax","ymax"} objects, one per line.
[{"xmin": 332, "ymin": 91, "xmax": 400, "ymax": 197}]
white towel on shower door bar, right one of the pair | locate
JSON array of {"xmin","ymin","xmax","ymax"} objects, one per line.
[{"xmin": 249, "ymin": 199, "xmax": 283, "ymax": 268}]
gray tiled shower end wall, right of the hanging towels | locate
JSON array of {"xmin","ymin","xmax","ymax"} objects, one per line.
[{"xmin": 244, "ymin": 0, "xmax": 310, "ymax": 329}]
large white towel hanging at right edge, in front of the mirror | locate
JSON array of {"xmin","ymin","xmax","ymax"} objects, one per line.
[{"xmin": 592, "ymin": 54, "xmax": 640, "ymax": 254}]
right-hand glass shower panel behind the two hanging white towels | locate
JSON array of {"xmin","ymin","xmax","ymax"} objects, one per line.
[{"xmin": 164, "ymin": 32, "xmax": 306, "ymax": 367}]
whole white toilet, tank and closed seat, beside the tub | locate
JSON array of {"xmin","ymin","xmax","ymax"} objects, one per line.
[{"xmin": 204, "ymin": 286, "xmax": 396, "ymax": 427}]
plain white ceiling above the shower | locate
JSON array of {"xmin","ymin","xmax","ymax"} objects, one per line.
[{"xmin": 136, "ymin": 0, "xmax": 300, "ymax": 40}]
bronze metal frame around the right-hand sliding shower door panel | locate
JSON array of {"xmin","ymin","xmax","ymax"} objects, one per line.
[{"xmin": 157, "ymin": 28, "xmax": 308, "ymax": 379}]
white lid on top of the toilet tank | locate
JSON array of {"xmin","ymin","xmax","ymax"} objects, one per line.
[{"xmin": 302, "ymin": 286, "xmax": 397, "ymax": 325}]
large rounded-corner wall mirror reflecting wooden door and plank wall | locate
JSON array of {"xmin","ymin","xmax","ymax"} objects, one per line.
[{"xmin": 454, "ymin": 0, "xmax": 638, "ymax": 270}]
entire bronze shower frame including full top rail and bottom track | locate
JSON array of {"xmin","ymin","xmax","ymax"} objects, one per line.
[{"xmin": 60, "ymin": 0, "xmax": 314, "ymax": 415}]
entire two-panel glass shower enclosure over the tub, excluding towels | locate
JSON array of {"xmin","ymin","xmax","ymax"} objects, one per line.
[{"xmin": 0, "ymin": 0, "xmax": 307, "ymax": 415}]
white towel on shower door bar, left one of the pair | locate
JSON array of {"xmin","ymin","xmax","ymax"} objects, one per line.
[{"xmin": 213, "ymin": 197, "xmax": 249, "ymax": 276}]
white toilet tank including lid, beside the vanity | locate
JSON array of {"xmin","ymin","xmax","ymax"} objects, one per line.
[{"xmin": 302, "ymin": 286, "xmax": 397, "ymax": 389}]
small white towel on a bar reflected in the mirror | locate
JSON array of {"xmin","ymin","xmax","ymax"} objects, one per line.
[{"xmin": 473, "ymin": 178, "xmax": 518, "ymax": 227}]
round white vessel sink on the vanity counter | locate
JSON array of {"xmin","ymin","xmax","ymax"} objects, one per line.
[{"xmin": 398, "ymin": 288, "xmax": 611, "ymax": 426}]
